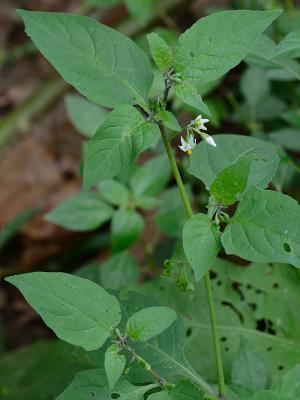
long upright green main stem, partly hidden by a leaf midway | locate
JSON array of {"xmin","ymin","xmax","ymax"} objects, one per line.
[{"xmin": 158, "ymin": 122, "xmax": 225, "ymax": 400}]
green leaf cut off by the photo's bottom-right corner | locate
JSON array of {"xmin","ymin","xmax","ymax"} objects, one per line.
[{"xmin": 273, "ymin": 364, "xmax": 300, "ymax": 400}]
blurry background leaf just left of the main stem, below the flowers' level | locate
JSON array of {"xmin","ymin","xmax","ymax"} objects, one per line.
[{"xmin": 129, "ymin": 154, "xmax": 171, "ymax": 198}]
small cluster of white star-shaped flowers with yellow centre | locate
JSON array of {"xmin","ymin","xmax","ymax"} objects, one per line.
[{"xmin": 179, "ymin": 115, "xmax": 216, "ymax": 155}]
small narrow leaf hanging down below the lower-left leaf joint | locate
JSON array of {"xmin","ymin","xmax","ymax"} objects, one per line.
[{"xmin": 104, "ymin": 343, "xmax": 126, "ymax": 389}]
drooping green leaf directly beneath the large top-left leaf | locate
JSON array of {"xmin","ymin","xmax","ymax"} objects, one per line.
[{"xmin": 83, "ymin": 105, "xmax": 159, "ymax": 188}]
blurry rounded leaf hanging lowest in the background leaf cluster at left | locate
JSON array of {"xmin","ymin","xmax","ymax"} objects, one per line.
[{"xmin": 111, "ymin": 209, "xmax": 144, "ymax": 252}]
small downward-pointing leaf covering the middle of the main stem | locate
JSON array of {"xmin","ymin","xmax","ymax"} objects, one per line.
[{"xmin": 182, "ymin": 214, "xmax": 221, "ymax": 281}]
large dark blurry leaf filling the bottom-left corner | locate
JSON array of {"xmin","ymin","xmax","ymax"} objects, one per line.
[{"xmin": 0, "ymin": 340, "xmax": 96, "ymax": 400}]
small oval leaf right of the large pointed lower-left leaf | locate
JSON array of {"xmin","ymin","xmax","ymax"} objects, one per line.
[{"xmin": 126, "ymin": 307, "xmax": 176, "ymax": 341}]
